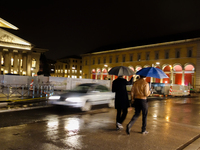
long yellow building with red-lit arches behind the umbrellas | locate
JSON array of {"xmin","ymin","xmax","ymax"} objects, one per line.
[{"xmin": 82, "ymin": 38, "xmax": 200, "ymax": 88}]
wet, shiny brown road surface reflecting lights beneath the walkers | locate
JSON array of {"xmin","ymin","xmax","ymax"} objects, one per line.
[{"xmin": 0, "ymin": 97, "xmax": 200, "ymax": 150}]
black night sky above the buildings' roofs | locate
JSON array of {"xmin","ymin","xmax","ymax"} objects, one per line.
[{"xmin": 0, "ymin": 0, "xmax": 200, "ymax": 59}]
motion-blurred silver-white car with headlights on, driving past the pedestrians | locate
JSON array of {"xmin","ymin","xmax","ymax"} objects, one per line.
[{"xmin": 49, "ymin": 83, "xmax": 115, "ymax": 111}]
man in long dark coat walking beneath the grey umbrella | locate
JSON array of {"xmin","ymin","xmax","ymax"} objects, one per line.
[{"xmin": 112, "ymin": 76, "xmax": 133, "ymax": 129}]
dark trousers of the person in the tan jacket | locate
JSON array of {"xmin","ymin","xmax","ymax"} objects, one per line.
[{"xmin": 128, "ymin": 99, "xmax": 148, "ymax": 132}]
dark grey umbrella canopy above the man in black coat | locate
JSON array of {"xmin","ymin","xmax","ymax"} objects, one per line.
[{"xmin": 108, "ymin": 66, "xmax": 135, "ymax": 76}]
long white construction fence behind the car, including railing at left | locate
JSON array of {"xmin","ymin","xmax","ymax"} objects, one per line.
[{"xmin": 0, "ymin": 75, "xmax": 112, "ymax": 100}]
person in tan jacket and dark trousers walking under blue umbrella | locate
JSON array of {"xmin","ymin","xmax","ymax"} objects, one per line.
[{"xmin": 126, "ymin": 76, "xmax": 151, "ymax": 135}]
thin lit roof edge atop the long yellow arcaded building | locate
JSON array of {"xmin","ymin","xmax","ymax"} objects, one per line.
[{"xmin": 82, "ymin": 38, "xmax": 200, "ymax": 56}]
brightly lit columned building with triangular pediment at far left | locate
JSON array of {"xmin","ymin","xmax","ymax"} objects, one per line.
[{"xmin": 0, "ymin": 18, "xmax": 48, "ymax": 76}]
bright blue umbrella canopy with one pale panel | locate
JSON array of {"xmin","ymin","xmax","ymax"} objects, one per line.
[{"xmin": 136, "ymin": 67, "xmax": 169, "ymax": 79}]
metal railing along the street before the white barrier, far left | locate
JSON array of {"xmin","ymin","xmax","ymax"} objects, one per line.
[{"xmin": 0, "ymin": 84, "xmax": 54, "ymax": 99}]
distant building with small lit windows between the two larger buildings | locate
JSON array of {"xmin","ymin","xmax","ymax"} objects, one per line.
[{"xmin": 51, "ymin": 56, "xmax": 82, "ymax": 78}]
